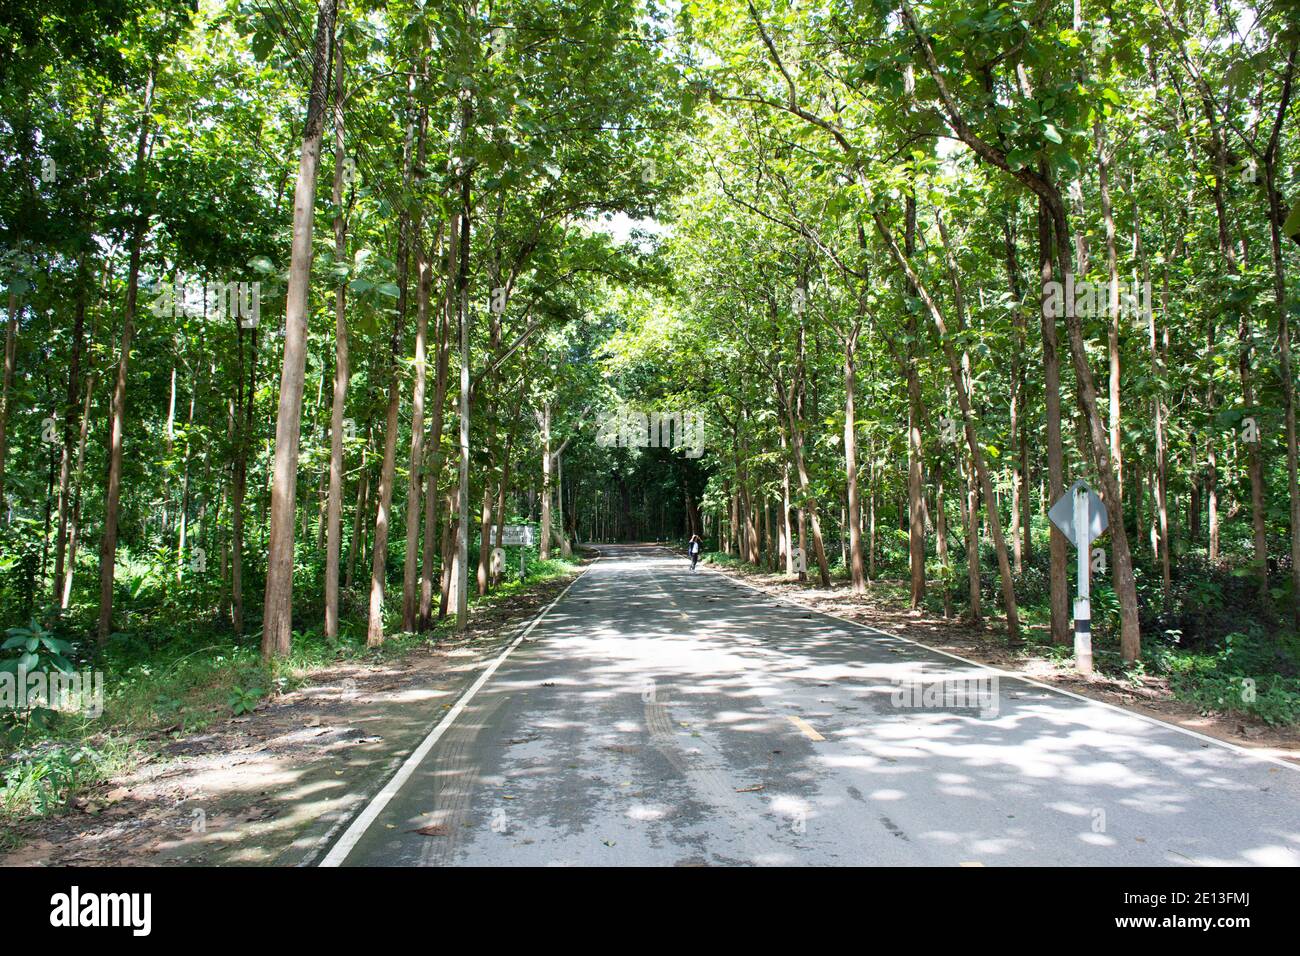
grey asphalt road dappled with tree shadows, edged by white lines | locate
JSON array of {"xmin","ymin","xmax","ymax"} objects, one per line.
[{"xmin": 327, "ymin": 548, "xmax": 1300, "ymax": 866}]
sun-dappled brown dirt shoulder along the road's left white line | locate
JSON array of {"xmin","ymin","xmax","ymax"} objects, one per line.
[{"xmin": 0, "ymin": 564, "xmax": 585, "ymax": 866}]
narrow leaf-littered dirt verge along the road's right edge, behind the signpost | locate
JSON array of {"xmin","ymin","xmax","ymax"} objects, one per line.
[{"xmin": 711, "ymin": 563, "xmax": 1300, "ymax": 763}]
